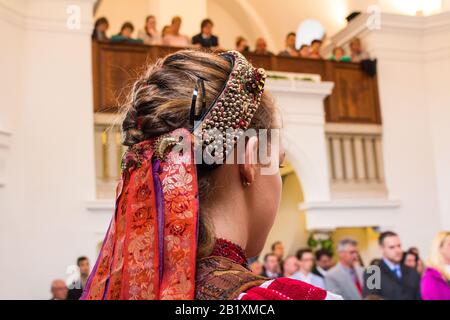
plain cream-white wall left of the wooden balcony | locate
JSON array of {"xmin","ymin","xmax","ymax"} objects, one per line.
[{"xmin": 0, "ymin": 0, "xmax": 97, "ymax": 299}]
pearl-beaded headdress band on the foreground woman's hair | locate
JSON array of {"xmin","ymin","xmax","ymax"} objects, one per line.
[{"xmin": 191, "ymin": 51, "xmax": 267, "ymax": 168}]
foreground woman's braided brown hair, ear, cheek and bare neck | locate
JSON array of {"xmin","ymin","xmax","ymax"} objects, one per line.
[{"xmin": 123, "ymin": 51, "xmax": 283, "ymax": 256}]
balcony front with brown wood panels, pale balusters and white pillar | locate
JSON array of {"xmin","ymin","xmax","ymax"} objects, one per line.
[{"xmin": 92, "ymin": 42, "xmax": 387, "ymax": 202}]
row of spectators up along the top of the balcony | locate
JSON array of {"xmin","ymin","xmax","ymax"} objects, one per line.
[{"xmin": 92, "ymin": 15, "xmax": 369, "ymax": 62}]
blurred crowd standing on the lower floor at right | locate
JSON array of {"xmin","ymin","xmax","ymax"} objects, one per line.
[{"xmin": 249, "ymin": 231, "xmax": 450, "ymax": 300}]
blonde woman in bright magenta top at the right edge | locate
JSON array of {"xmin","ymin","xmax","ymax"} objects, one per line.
[{"xmin": 421, "ymin": 232, "xmax": 450, "ymax": 300}]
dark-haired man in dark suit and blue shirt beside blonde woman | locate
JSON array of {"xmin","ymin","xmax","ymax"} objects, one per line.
[{"xmin": 364, "ymin": 231, "xmax": 420, "ymax": 300}]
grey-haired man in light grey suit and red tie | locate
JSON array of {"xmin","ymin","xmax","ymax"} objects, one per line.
[{"xmin": 325, "ymin": 238, "xmax": 364, "ymax": 300}]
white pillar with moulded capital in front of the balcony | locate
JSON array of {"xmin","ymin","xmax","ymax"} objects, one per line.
[{"xmin": 267, "ymin": 81, "xmax": 333, "ymax": 202}]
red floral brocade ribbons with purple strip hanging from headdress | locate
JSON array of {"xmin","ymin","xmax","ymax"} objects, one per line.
[{"xmin": 82, "ymin": 129, "xmax": 199, "ymax": 300}]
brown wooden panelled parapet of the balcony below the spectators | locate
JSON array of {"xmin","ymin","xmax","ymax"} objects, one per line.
[{"xmin": 92, "ymin": 42, "xmax": 381, "ymax": 124}]
